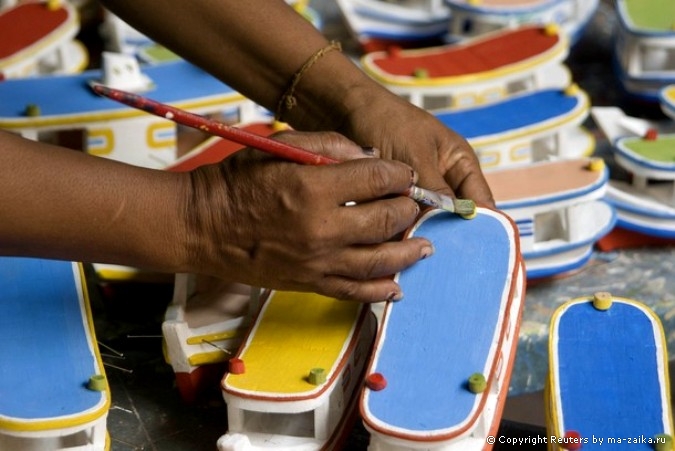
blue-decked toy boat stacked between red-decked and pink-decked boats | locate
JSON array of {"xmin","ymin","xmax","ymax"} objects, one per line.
[{"xmin": 432, "ymin": 85, "xmax": 595, "ymax": 170}]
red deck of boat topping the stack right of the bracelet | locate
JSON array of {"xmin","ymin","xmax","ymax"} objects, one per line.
[{"xmin": 373, "ymin": 26, "xmax": 560, "ymax": 78}]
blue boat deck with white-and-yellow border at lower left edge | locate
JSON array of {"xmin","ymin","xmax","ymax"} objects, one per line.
[{"xmin": 0, "ymin": 257, "xmax": 109, "ymax": 430}]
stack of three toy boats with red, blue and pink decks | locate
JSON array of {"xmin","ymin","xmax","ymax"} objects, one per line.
[{"xmin": 361, "ymin": 25, "xmax": 615, "ymax": 280}]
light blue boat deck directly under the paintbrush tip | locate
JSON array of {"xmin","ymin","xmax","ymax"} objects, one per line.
[{"xmin": 362, "ymin": 212, "xmax": 516, "ymax": 435}]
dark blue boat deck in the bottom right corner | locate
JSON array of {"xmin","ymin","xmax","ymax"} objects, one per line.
[{"xmin": 556, "ymin": 299, "xmax": 672, "ymax": 450}]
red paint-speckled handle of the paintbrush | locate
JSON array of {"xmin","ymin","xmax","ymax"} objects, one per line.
[{"xmin": 93, "ymin": 84, "xmax": 339, "ymax": 165}]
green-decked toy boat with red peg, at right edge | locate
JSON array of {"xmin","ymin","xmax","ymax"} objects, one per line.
[{"xmin": 607, "ymin": 133, "xmax": 675, "ymax": 239}]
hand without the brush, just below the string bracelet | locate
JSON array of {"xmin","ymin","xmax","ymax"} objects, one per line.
[{"xmin": 340, "ymin": 86, "xmax": 494, "ymax": 207}]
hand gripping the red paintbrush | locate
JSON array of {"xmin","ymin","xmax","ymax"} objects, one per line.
[{"xmin": 180, "ymin": 132, "xmax": 432, "ymax": 302}]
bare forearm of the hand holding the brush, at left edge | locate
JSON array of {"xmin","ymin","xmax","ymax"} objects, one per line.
[{"xmin": 0, "ymin": 132, "xmax": 185, "ymax": 272}]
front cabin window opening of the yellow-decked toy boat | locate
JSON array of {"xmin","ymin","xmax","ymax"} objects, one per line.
[{"xmin": 243, "ymin": 410, "xmax": 314, "ymax": 437}]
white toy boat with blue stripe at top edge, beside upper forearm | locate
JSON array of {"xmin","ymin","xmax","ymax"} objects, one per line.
[{"xmin": 337, "ymin": 0, "xmax": 450, "ymax": 49}]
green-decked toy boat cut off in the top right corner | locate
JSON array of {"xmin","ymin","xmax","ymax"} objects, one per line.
[{"xmin": 614, "ymin": 0, "xmax": 675, "ymax": 103}]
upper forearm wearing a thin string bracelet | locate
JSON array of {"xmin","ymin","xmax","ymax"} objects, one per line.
[{"xmin": 102, "ymin": 0, "xmax": 379, "ymax": 130}]
